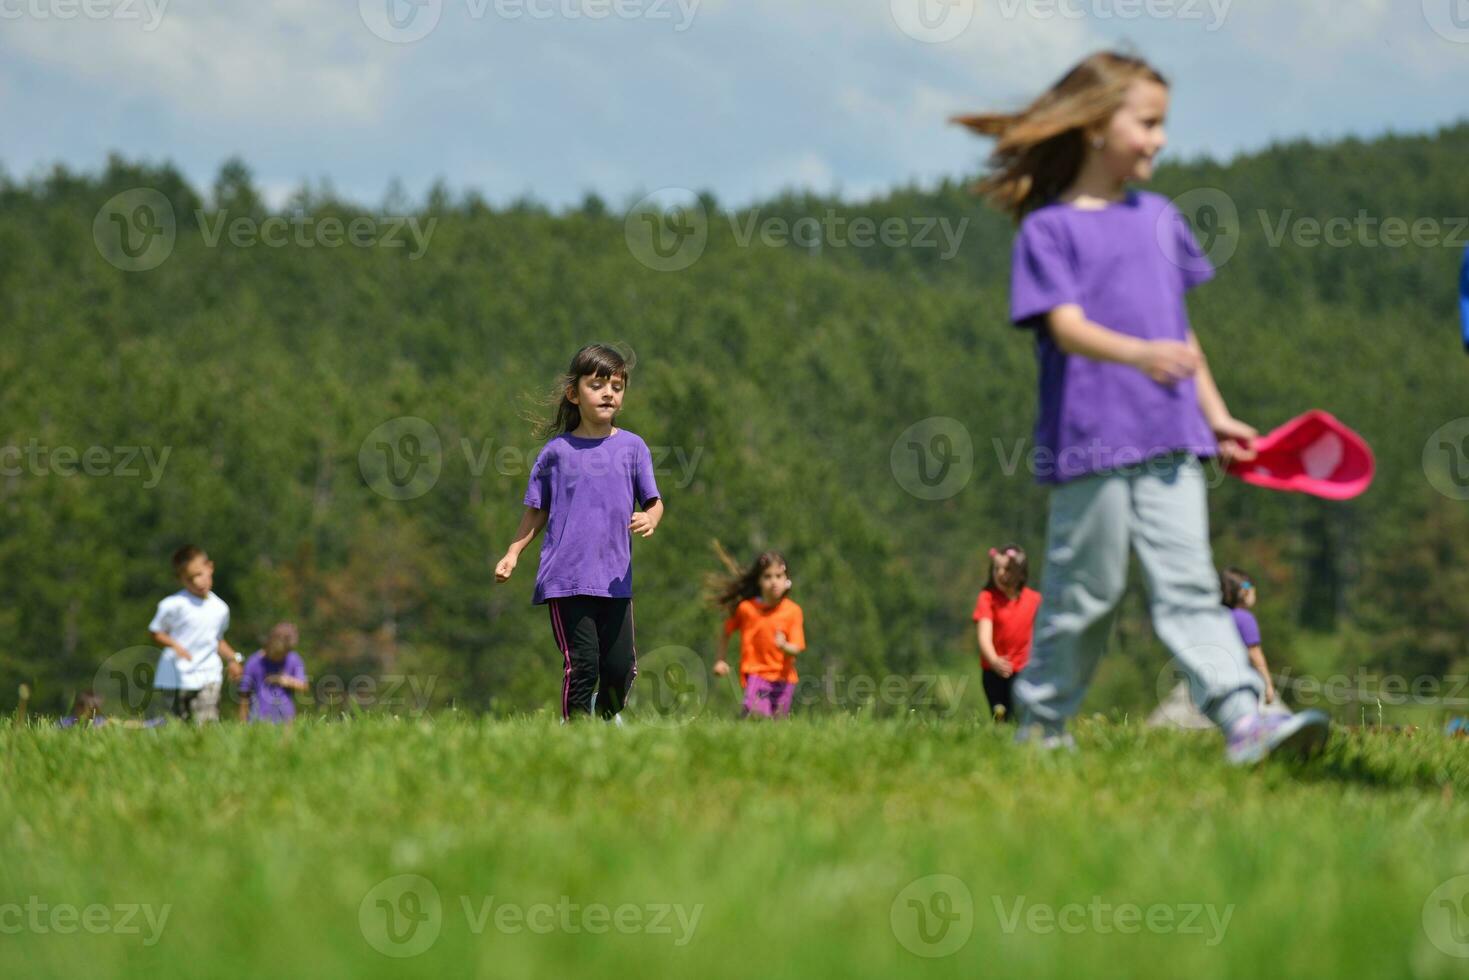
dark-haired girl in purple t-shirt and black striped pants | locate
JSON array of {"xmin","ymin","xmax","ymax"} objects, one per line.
[{"xmin": 495, "ymin": 344, "xmax": 663, "ymax": 720}]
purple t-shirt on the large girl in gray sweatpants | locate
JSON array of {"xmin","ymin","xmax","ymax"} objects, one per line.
[{"xmin": 1011, "ymin": 191, "xmax": 1218, "ymax": 483}]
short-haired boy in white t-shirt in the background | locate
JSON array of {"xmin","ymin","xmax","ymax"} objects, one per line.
[{"xmin": 148, "ymin": 545, "xmax": 242, "ymax": 724}]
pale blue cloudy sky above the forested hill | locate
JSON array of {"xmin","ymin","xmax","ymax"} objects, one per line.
[{"xmin": 0, "ymin": 0, "xmax": 1469, "ymax": 207}]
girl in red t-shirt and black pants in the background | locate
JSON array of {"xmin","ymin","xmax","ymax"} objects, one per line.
[{"xmin": 974, "ymin": 545, "xmax": 1040, "ymax": 721}]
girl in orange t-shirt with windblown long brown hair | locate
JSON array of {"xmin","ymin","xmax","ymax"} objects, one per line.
[{"xmin": 710, "ymin": 545, "xmax": 806, "ymax": 718}]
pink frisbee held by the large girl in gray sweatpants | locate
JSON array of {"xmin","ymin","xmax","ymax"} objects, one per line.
[{"xmin": 1230, "ymin": 408, "xmax": 1376, "ymax": 500}]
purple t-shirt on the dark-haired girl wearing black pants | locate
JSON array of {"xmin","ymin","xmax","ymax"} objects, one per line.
[{"xmin": 524, "ymin": 429, "xmax": 658, "ymax": 604}]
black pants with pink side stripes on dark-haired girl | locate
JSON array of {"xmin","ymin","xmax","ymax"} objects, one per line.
[{"xmin": 546, "ymin": 595, "xmax": 638, "ymax": 720}]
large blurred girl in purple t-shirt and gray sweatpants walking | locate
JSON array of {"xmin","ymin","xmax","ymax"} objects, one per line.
[{"xmin": 956, "ymin": 51, "xmax": 1327, "ymax": 763}]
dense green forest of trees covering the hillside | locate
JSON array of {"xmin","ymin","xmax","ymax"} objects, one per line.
[{"xmin": 0, "ymin": 123, "xmax": 1469, "ymax": 713}]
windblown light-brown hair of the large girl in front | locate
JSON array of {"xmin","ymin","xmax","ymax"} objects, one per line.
[{"xmin": 949, "ymin": 51, "xmax": 1168, "ymax": 222}]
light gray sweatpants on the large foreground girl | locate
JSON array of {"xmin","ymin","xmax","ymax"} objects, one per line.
[{"xmin": 1015, "ymin": 453, "xmax": 1263, "ymax": 733}]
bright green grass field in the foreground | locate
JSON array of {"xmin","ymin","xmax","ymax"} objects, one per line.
[{"xmin": 0, "ymin": 717, "xmax": 1469, "ymax": 977}]
